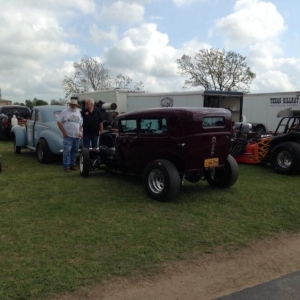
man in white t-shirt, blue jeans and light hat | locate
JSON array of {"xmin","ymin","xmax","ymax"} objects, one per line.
[{"xmin": 57, "ymin": 97, "xmax": 82, "ymax": 172}]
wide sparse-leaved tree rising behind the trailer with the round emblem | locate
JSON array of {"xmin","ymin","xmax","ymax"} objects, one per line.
[{"xmin": 176, "ymin": 48, "xmax": 256, "ymax": 93}]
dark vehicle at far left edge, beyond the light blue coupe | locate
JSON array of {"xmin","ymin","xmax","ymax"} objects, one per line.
[{"xmin": 0, "ymin": 105, "xmax": 30, "ymax": 139}]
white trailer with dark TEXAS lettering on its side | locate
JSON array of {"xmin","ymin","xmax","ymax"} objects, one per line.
[{"xmin": 243, "ymin": 92, "xmax": 300, "ymax": 132}]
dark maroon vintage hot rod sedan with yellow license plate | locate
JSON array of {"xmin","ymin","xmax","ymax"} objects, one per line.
[{"xmin": 80, "ymin": 108, "xmax": 238, "ymax": 201}]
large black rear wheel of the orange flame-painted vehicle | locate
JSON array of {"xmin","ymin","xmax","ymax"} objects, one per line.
[{"xmin": 271, "ymin": 142, "xmax": 300, "ymax": 175}]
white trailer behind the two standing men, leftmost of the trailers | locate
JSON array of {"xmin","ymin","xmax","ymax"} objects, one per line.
[{"xmin": 72, "ymin": 89, "xmax": 144, "ymax": 113}]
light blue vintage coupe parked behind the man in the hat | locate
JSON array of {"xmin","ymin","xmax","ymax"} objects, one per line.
[{"xmin": 11, "ymin": 105, "xmax": 67, "ymax": 163}]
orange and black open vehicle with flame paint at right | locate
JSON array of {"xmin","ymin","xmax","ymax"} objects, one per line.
[{"xmin": 230, "ymin": 109, "xmax": 300, "ymax": 175}]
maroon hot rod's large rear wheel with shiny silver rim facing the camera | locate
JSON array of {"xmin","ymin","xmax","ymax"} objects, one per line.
[{"xmin": 144, "ymin": 159, "xmax": 181, "ymax": 202}]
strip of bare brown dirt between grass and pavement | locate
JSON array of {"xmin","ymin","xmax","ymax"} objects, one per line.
[{"xmin": 55, "ymin": 233, "xmax": 300, "ymax": 300}]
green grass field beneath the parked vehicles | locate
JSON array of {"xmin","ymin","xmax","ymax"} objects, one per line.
[{"xmin": 0, "ymin": 142, "xmax": 300, "ymax": 299}]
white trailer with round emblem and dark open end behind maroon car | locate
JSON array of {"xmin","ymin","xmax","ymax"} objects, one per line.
[{"xmin": 126, "ymin": 90, "xmax": 243, "ymax": 122}]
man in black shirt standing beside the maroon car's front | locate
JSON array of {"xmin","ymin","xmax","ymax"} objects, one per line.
[{"xmin": 81, "ymin": 99, "xmax": 103, "ymax": 148}]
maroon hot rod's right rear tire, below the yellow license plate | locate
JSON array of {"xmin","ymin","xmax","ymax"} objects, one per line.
[{"xmin": 205, "ymin": 154, "xmax": 239, "ymax": 188}]
